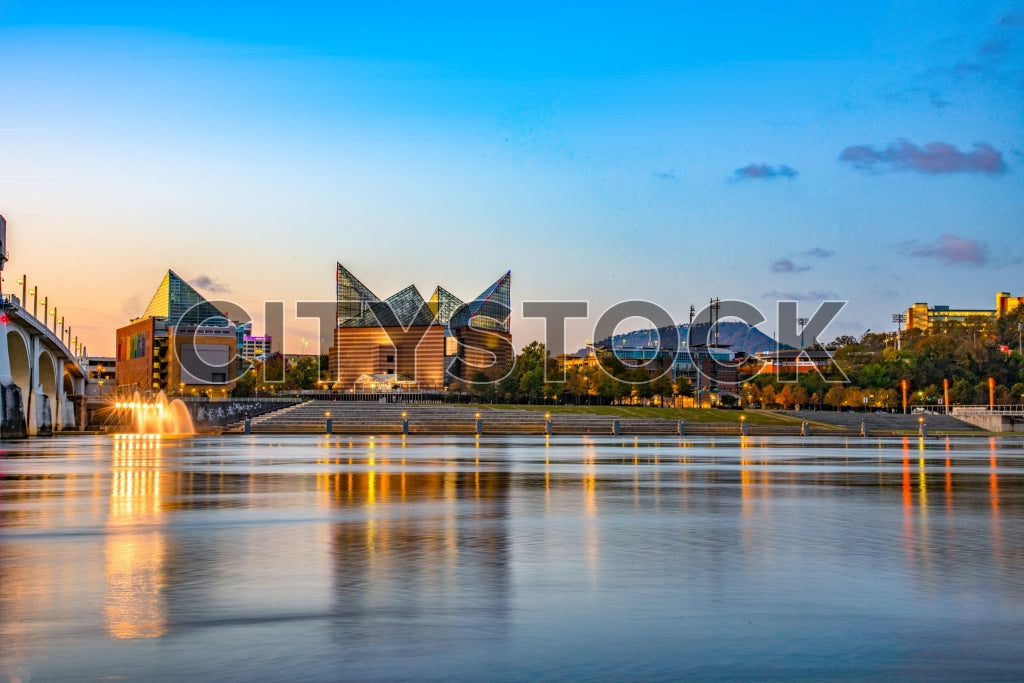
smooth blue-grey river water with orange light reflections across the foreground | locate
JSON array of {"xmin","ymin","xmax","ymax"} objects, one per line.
[{"xmin": 0, "ymin": 436, "xmax": 1024, "ymax": 681}]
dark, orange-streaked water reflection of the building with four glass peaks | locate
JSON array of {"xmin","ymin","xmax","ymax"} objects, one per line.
[{"xmin": 317, "ymin": 444, "xmax": 510, "ymax": 650}]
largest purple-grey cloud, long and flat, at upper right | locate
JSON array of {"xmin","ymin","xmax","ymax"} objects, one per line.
[{"xmin": 839, "ymin": 139, "xmax": 1007, "ymax": 175}]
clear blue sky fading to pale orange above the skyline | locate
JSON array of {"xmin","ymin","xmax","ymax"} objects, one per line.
[{"xmin": 0, "ymin": 0, "xmax": 1024, "ymax": 355}]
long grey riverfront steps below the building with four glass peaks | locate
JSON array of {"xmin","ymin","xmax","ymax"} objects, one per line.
[{"xmin": 234, "ymin": 400, "xmax": 859, "ymax": 436}]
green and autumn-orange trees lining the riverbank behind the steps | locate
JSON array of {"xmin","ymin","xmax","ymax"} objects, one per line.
[{"xmin": 232, "ymin": 310, "xmax": 1024, "ymax": 410}]
